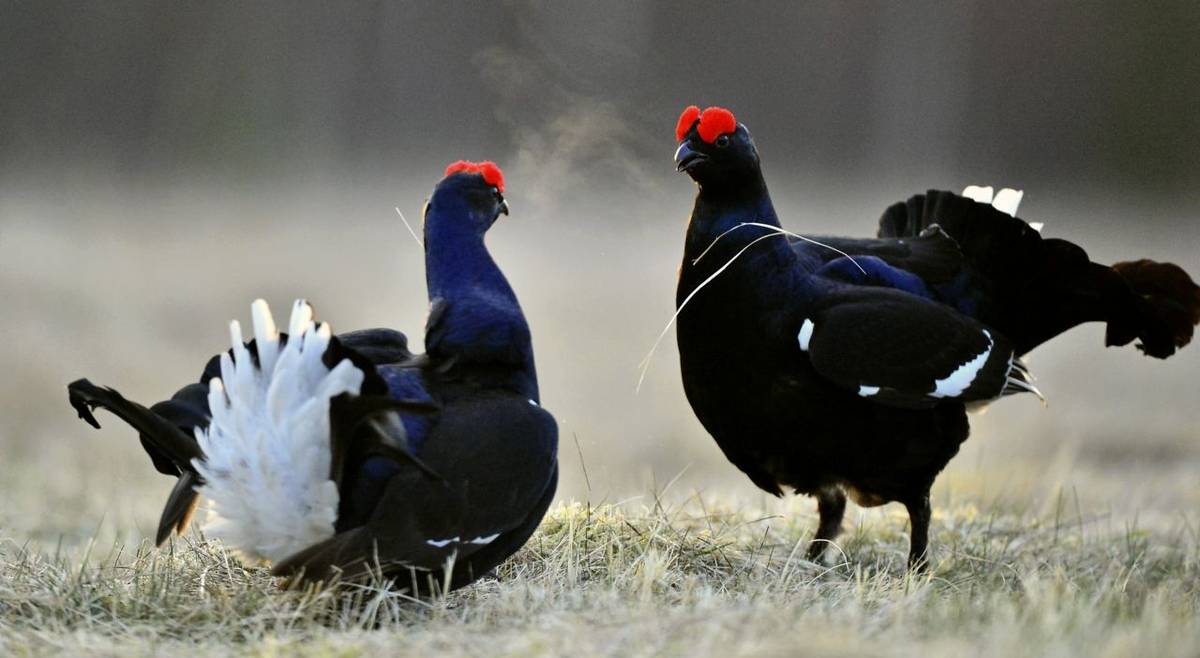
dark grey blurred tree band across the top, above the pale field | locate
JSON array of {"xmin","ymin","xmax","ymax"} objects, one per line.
[{"xmin": 0, "ymin": 0, "xmax": 1200, "ymax": 190}]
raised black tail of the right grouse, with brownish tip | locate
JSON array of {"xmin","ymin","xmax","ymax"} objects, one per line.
[{"xmin": 878, "ymin": 190, "xmax": 1200, "ymax": 359}]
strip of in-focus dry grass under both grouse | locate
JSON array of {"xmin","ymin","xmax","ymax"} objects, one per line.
[{"xmin": 0, "ymin": 495, "xmax": 1200, "ymax": 657}]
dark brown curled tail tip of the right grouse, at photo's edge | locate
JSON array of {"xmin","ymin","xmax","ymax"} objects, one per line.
[{"xmin": 1104, "ymin": 258, "xmax": 1200, "ymax": 359}]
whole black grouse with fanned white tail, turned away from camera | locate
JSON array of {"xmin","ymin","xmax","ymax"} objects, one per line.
[{"xmin": 68, "ymin": 162, "xmax": 558, "ymax": 593}]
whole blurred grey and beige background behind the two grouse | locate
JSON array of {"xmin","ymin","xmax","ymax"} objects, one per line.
[{"xmin": 0, "ymin": 0, "xmax": 1200, "ymax": 544}]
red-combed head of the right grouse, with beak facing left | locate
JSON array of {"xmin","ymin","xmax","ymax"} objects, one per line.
[{"xmin": 676, "ymin": 106, "xmax": 760, "ymax": 187}]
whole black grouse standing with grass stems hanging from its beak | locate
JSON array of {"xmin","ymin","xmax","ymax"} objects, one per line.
[{"xmin": 676, "ymin": 106, "xmax": 1200, "ymax": 568}]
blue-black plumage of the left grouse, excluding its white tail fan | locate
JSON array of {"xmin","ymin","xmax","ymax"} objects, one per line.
[{"xmin": 64, "ymin": 165, "xmax": 558, "ymax": 593}]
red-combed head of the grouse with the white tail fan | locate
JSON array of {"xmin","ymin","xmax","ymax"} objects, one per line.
[{"xmin": 425, "ymin": 160, "xmax": 509, "ymax": 234}]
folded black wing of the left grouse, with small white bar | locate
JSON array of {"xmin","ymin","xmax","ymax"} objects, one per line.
[{"xmin": 275, "ymin": 394, "xmax": 558, "ymax": 587}]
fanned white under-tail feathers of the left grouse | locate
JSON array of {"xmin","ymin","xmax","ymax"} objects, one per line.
[{"xmin": 194, "ymin": 299, "xmax": 364, "ymax": 561}]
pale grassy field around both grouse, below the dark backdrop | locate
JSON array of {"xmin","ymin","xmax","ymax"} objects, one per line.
[{"xmin": 0, "ymin": 183, "xmax": 1200, "ymax": 657}]
